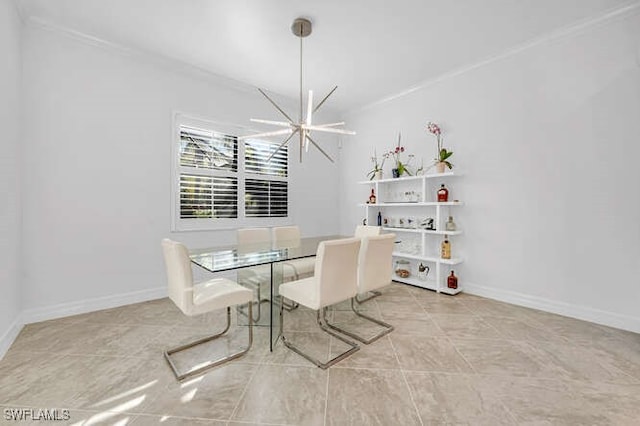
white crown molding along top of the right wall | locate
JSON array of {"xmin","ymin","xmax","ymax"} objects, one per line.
[{"xmin": 344, "ymin": 0, "xmax": 640, "ymax": 116}]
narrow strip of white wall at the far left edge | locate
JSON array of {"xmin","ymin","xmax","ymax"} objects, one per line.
[{"xmin": 0, "ymin": 0, "xmax": 22, "ymax": 358}]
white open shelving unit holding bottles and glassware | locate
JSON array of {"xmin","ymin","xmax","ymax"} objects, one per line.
[{"xmin": 358, "ymin": 172, "xmax": 464, "ymax": 295}]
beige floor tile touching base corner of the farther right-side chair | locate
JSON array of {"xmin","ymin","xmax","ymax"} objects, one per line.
[{"xmin": 389, "ymin": 333, "xmax": 473, "ymax": 372}]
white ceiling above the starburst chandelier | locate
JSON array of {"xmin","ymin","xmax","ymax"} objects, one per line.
[{"xmin": 18, "ymin": 0, "xmax": 638, "ymax": 110}]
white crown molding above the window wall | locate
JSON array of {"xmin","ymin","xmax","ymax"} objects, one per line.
[{"xmin": 26, "ymin": 16, "xmax": 278, "ymax": 99}]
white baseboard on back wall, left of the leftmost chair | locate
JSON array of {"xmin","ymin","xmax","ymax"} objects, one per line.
[{"xmin": 22, "ymin": 286, "xmax": 167, "ymax": 324}]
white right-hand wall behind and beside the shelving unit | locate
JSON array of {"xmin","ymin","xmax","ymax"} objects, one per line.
[{"xmin": 341, "ymin": 9, "xmax": 640, "ymax": 332}]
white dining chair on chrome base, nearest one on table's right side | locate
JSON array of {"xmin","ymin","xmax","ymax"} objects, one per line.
[{"xmin": 279, "ymin": 238, "xmax": 360, "ymax": 369}]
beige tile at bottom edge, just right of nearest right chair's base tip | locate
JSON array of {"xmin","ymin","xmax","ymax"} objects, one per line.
[{"xmin": 326, "ymin": 368, "xmax": 420, "ymax": 425}]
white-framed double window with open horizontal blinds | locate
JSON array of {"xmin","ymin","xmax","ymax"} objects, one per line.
[{"xmin": 172, "ymin": 116, "xmax": 289, "ymax": 230}]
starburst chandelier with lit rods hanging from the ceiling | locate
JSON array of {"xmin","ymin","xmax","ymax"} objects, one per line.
[{"xmin": 239, "ymin": 18, "xmax": 356, "ymax": 163}]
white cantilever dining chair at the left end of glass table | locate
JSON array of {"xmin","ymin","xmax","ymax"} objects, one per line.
[{"xmin": 162, "ymin": 238, "xmax": 253, "ymax": 380}]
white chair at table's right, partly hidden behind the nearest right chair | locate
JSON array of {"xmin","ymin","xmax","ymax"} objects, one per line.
[{"xmin": 327, "ymin": 234, "xmax": 395, "ymax": 344}]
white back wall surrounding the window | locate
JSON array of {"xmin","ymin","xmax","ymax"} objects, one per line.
[{"xmin": 24, "ymin": 23, "xmax": 339, "ymax": 321}]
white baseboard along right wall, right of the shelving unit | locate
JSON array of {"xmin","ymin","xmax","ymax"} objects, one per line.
[{"xmin": 464, "ymin": 283, "xmax": 640, "ymax": 333}]
